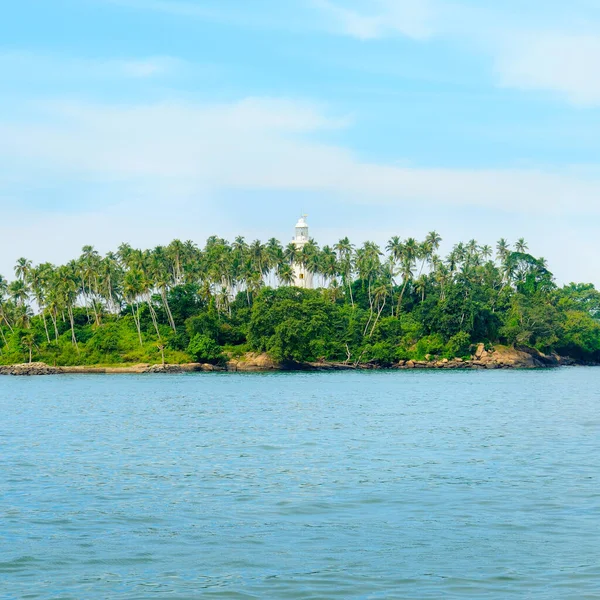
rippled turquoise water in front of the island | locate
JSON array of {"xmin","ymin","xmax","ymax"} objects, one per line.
[{"xmin": 0, "ymin": 368, "xmax": 600, "ymax": 600}]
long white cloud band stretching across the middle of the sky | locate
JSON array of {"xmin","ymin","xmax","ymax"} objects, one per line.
[{"xmin": 0, "ymin": 98, "xmax": 600, "ymax": 214}]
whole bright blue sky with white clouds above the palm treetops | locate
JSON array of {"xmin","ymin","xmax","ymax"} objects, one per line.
[{"xmin": 0, "ymin": 0, "xmax": 600, "ymax": 285}]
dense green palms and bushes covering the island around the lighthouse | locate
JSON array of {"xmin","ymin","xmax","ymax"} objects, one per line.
[{"xmin": 0, "ymin": 232, "xmax": 600, "ymax": 365}]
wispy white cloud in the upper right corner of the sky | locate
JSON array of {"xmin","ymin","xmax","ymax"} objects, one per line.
[{"xmin": 312, "ymin": 0, "xmax": 600, "ymax": 106}]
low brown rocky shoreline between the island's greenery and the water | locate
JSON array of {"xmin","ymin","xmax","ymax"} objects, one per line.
[{"xmin": 0, "ymin": 344, "xmax": 585, "ymax": 376}]
